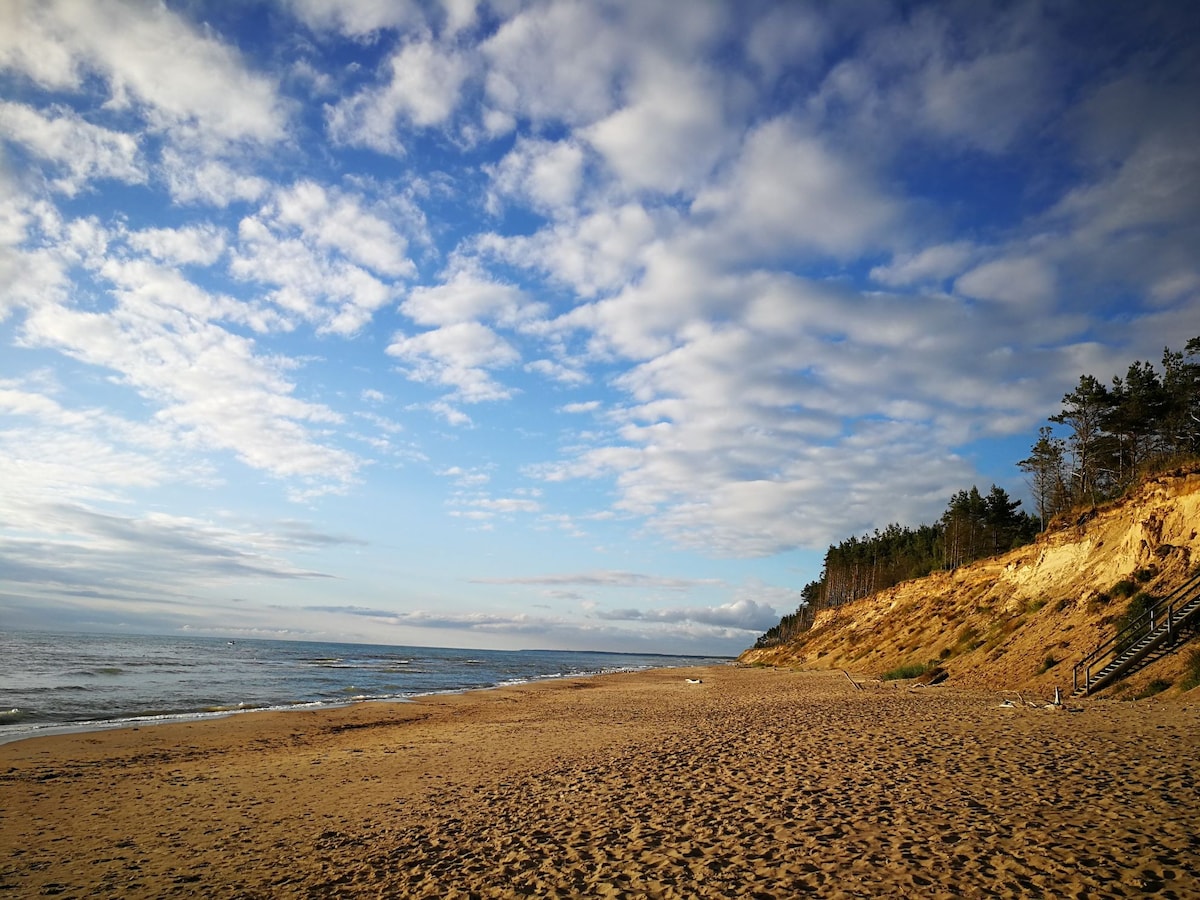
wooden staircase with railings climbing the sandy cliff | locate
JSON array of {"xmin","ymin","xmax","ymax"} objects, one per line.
[{"xmin": 1072, "ymin": 572, "xmax": 1200, "ymax": 697}]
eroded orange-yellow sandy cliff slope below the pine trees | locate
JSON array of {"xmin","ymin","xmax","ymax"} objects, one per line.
[{"xmin": 740, "ymin": 467, "xmax": 1200, "ymax": 696}]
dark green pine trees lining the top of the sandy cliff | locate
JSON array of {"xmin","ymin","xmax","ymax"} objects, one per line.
[{"xmin": 755, "ymin": 337, "xmax": 1200, "ymax": 648}]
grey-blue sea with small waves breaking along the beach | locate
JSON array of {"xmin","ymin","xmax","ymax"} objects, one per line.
[{"xmin": 0, "ymin": 631, "xmax": 730, "ymax": 744}]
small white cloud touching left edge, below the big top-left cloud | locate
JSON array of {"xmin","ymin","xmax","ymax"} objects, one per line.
[{"xmin": 0, "ymin": 101, "xmax": 146, "ymax": 194}]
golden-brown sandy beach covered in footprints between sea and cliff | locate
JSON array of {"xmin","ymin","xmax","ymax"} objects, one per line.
[{"xmin": 0, "ymin": 667, "xmax": 1200, "ymax": 898}]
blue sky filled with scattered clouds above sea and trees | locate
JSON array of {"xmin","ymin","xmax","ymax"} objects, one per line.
[{"xmin": 0, "ymin": 0, "xmax": 1200, "ymax": 653}]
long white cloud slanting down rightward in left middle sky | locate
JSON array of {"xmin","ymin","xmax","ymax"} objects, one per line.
[{"xmin": 5, "ymin": 221, "xmax": 359, "ymax": 487}]
